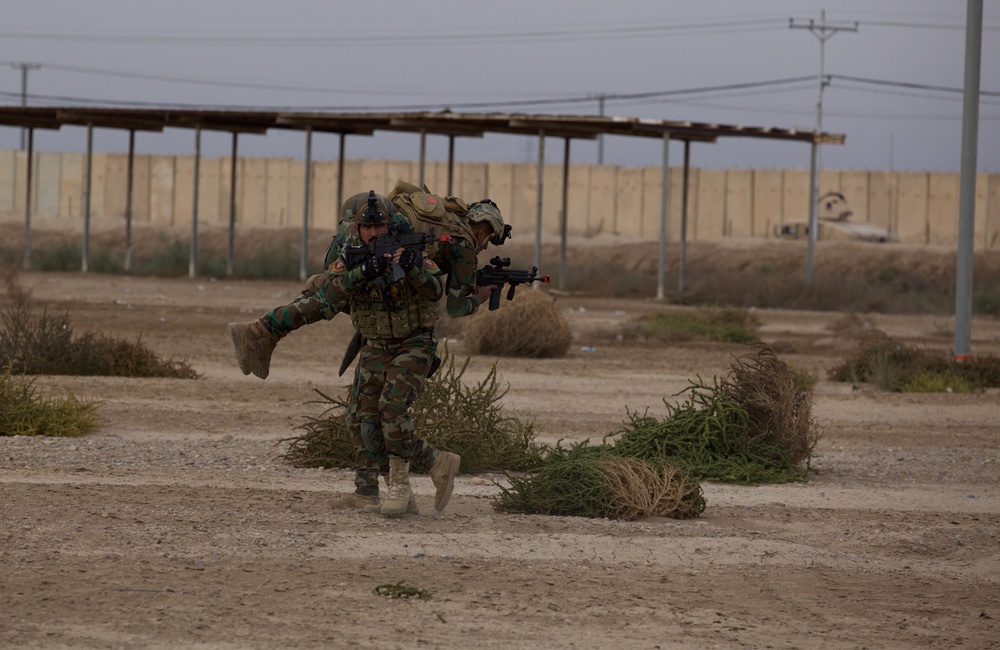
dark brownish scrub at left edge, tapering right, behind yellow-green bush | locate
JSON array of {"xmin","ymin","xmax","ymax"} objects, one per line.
[{"xmin": 0, "ymin": 290, "xmax": 199, "ymax": 379}]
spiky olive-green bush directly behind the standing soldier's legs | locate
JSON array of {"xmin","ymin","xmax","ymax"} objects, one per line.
[{"xmin": 284, "ymin": 347, "xmax": 545, "ymax": 474}]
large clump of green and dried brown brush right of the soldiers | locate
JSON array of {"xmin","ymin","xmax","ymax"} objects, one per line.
[{"xmin": 493, "ymin": 345, "xmax": 819, "ymax": 519}]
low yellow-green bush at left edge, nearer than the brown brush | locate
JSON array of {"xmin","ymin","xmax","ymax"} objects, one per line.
[{"xmin": 0, "ymin": 367, "xmax": 98, "ymax": 436}]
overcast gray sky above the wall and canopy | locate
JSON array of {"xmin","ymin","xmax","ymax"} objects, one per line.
[{"xmin": 0, "ymin": 0, "xmax": 1000, "ymax": 173}]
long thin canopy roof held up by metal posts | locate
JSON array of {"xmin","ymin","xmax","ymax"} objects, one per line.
[{"xmin": 0, "ymin": 106, "xmax": 845, "ymax": 144}]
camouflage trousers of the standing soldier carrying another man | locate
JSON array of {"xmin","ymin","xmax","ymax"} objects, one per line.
[{"xmin": 345, "ymin": 332, "xmax": 437, "ymax": 495}]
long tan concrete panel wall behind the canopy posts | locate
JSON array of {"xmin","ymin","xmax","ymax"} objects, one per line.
[{"xmin": 0, "ymin": 150, "xmax": 1000, "ymax": 250}]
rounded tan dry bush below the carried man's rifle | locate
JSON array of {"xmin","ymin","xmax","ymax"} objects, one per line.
[{"xmin": 463, "ymin": 288, "xmax": 572, "ymax": 359}]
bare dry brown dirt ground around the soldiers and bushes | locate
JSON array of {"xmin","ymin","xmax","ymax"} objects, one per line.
[{"xmin": 0, "ymin": 273, "xmax": 1000, "ymax": 649}]
